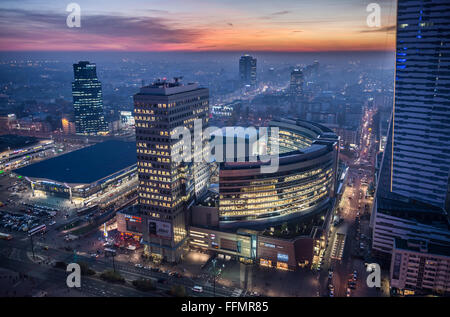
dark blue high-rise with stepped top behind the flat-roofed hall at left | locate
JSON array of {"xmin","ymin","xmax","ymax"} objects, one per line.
[{"xmin": 72, "ymin": 62, "xmax": 108, "ymax": 135}]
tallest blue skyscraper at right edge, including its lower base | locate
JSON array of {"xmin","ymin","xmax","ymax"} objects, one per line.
[{"xmin": 371, "ymin": 0, "xmax": 450, "ymax": 254}]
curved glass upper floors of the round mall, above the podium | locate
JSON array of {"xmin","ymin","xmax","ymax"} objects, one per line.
[{"xmin": 219, "ymin": 119, "xmax": 339, "ymax": 227}]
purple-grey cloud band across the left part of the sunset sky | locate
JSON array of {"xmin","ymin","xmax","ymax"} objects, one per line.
[{"xmin": 0, "ymin": 9, "xmax": 202, "ymax": 44}]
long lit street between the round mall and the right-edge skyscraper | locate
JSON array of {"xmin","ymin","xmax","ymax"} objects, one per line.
[{"xmin": 319, "ymin": 105, "xmax": 381, "ymax": 297}]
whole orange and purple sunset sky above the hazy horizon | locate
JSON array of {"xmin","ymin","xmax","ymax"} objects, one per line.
[{"xmin": 0, "ymin": 0, "xmax": 396, "ymax": 52}]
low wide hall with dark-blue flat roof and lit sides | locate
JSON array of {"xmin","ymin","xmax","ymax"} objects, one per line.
[{"xmin": 13, "ymin": 140, "xmax": 137, "ymax": 202}]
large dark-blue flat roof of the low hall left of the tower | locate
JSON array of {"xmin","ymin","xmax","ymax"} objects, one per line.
[{"xmin": 14, "ymin": 140, "xmax": 137, "ymax": 184}]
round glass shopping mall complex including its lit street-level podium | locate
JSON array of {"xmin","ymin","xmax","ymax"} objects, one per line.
[{"xmin": 118, "ymin": 119, "xmax": 343, "ymax": 270}]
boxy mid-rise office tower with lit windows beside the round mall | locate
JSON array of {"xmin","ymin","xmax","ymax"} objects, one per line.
[{"xmin": 134, "ymin": 78, "xmax": 209, "ymax": 262}]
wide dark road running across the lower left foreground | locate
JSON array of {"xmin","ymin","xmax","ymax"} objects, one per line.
[{"xmin": 0, "ymin": 238, "xmax": 234, "ymax": 297}]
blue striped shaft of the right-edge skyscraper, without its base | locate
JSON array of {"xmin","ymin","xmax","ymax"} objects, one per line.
[{"xmin": 389, "ymin": 0, "xmax": 450, "ymax": 208}]
